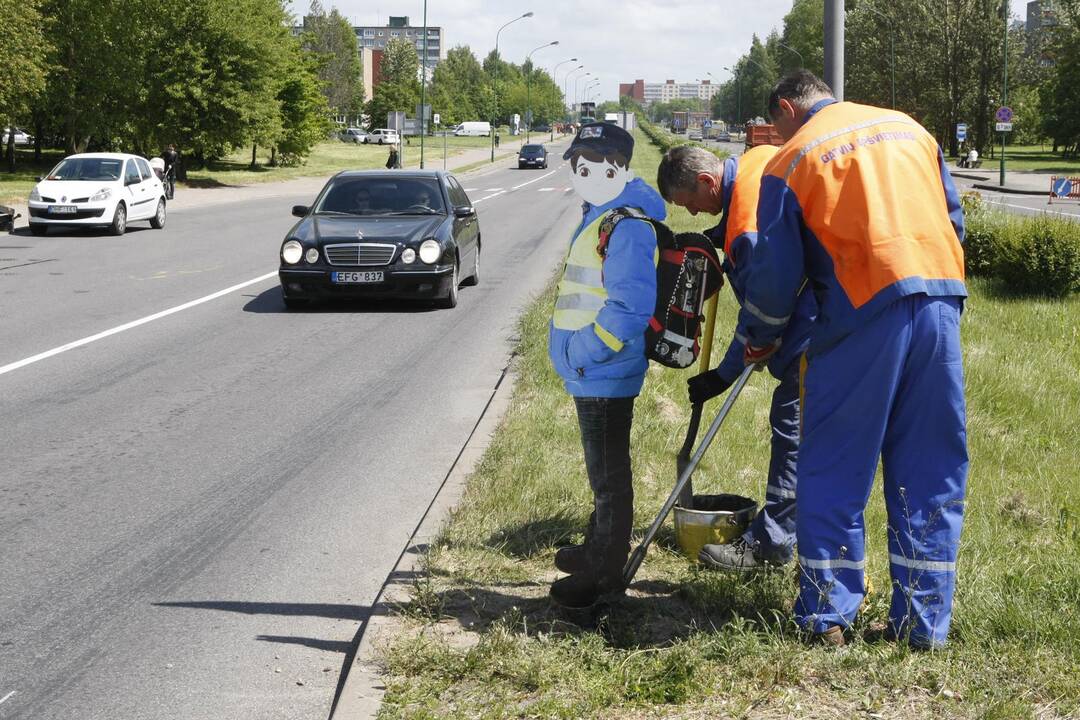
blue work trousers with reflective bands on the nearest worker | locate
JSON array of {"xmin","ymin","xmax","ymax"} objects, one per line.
[{"xmin": 795, "ymin": 295, "xmax": 968, "ymax": 648}]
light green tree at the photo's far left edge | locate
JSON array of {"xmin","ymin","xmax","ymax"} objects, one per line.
[{"xmin": 0, "ymin": 0, "xmax": 49, "ymax": 173}]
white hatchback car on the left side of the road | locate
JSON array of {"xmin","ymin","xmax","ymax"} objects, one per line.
[{"xmin": 27, "ymin": 152, "xmax": 165, "ymax": 235}]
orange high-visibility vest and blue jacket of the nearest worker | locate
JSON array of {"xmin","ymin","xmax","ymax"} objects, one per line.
[{"xmin": 740, "ymin": 100, "xmax": 968, "ymax": 354}]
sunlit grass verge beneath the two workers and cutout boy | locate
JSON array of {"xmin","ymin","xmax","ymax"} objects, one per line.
[{"xmin": 380, "ymin": 131, "xmax": 1080, "ymax": 719}]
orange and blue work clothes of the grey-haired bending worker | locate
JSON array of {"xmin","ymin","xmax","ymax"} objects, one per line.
[{"xmin": 706, "ymin": 145, "xmax": 818, "ymax": 565}]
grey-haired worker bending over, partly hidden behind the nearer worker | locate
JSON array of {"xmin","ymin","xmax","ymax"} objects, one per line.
[{"xmin": 657, "ymin": 145, "xmax": 818, "ymax": 571}]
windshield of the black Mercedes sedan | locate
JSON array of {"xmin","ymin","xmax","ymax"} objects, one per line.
[{"xmin": 315, "ymin": 177, "xmax": 446, "ymax": 215}]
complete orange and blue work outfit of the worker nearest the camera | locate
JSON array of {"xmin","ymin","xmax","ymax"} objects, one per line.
[{"xmin": 740, "ymin": 100, "xmax": 968, "ymax": 647}]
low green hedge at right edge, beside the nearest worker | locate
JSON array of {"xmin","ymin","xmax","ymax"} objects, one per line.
[{"xmin": 961, "ymin": 192, "xmax": 1080, "ymax": 297}]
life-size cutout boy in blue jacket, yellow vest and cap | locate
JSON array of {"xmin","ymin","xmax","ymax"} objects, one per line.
[{"xmin": 549, "ymin": 123, "xmax": 666, "ymax": 608}]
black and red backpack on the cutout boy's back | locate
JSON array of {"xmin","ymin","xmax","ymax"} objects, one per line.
[{"xmin": 596, "ymin": 207, "xmax": 724, "ymax": 368}]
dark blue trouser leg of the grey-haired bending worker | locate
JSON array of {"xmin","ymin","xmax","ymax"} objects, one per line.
[{"xmin": 743, "ymin": 357, "xmax": 799, "ymax": 565}]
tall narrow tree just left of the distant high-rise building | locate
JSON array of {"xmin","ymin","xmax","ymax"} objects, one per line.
[{"xmin": 301, "ymin": 0, "xmax": 365, "ymax": 118}]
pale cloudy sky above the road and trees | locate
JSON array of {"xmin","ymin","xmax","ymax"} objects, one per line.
[{"xmin": 293, "ymin": 0, "xmax": 1027, "ymax": 104}]
